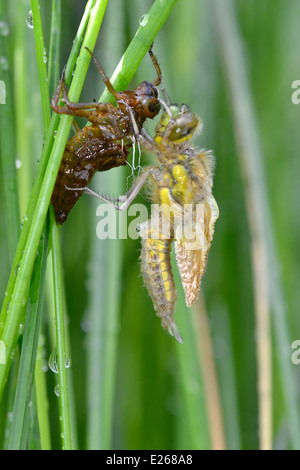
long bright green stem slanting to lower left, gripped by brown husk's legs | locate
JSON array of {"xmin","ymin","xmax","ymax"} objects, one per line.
[{"xmin": 0, "ymin": 0, "xmax": 107, "ymax": 404}]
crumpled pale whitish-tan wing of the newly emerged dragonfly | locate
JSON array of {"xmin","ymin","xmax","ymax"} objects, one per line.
[{"xmin": 175, "ymin": 196, "xmax": 219, "ymax": 307}]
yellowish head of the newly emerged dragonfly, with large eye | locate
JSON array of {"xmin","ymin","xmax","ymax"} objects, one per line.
[{"xmin": 155, "ymin": 100, "xmax": 202, "ymax": 144}]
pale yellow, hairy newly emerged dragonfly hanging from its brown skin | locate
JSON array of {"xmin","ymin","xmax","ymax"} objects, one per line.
[{"xmin": 78, "ymin": 102, "xmax": 219, "ymax": 343}]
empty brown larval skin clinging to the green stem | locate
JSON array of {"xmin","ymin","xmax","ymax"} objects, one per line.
[{"xmin": 51, "ymin": 48, "xmax": 161, "ymax": 224}]
